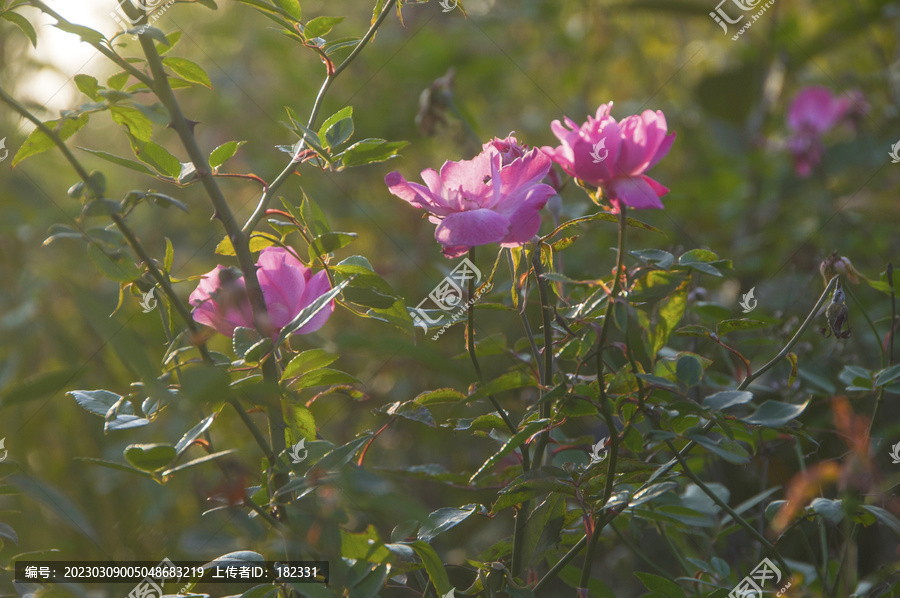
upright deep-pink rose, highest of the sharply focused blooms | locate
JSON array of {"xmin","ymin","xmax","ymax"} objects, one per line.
[{"xmin": 543, "ymin": 102, "xmax": 675, "ymax": 210}]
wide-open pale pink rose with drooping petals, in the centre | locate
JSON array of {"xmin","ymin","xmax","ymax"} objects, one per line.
[{"xmin": 384, "ymin": 136, "xmax": 556, "ymax": 258}]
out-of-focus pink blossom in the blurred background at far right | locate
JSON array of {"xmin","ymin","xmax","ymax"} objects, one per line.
[{"xmin": 787, "ymin": 85, "xmax": 868, "ymax": 177}]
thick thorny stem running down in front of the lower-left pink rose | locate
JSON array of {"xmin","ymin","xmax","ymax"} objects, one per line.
[{"xmin": 140, "ymin": 35, "xmax": 287, "ymax": 502}]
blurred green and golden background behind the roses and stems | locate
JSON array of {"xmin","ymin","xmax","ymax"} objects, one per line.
[{"xmin": 0, "ymin": 0, "xmax": 900, "ymax": 595}]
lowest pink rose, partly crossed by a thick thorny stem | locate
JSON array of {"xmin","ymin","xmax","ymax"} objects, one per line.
[{"xmin": 189, "ymin": 247, "xmax": 334, "ymax": 338}]
